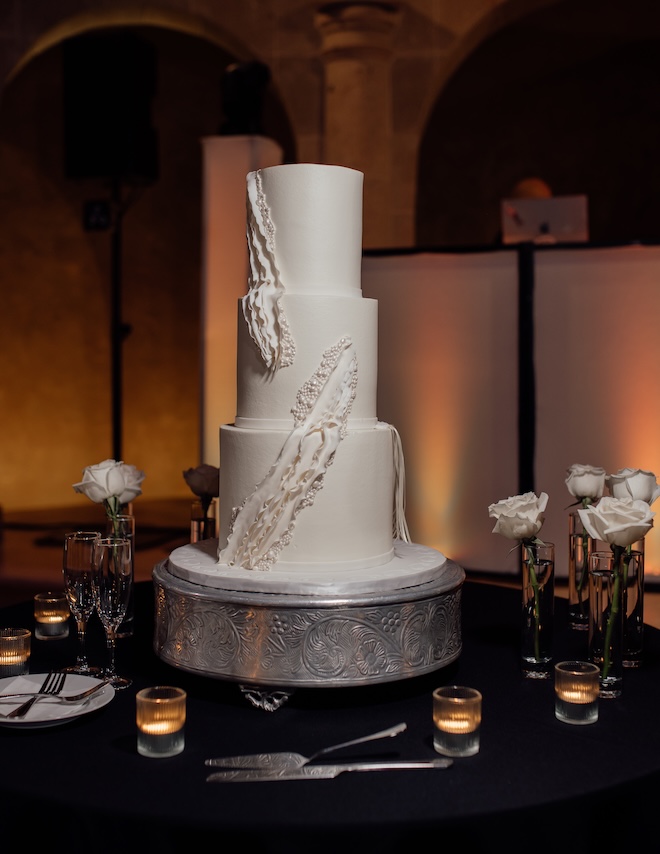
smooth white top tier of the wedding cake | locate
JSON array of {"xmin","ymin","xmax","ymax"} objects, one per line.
[{"xmin": 248, "ymin": 163, "xmax": 364, "ymax": 296}]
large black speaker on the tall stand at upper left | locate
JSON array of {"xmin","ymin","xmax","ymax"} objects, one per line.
[{"xmin": 62, "ymin": 30, "xmax": 158, "ymax": 184}]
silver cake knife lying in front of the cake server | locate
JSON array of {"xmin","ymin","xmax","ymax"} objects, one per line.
[{"xmin": 206, "ymin": 759, "xmax": 453, "ymax": 783}]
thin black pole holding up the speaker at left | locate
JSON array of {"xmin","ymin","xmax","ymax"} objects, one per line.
[{"xmin": 110, "ymin": 178, "xmax": 124, "ymax": 460}]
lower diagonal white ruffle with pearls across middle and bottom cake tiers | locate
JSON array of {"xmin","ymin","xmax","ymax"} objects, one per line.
[{"xmin": 218, "ymin": 338, "xmax": 357, "ymax": 571}]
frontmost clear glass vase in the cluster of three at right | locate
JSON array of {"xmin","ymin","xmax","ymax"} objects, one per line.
[{"xmin": 589, "ymin": 551, "xmax": 626, "ymax": 698}]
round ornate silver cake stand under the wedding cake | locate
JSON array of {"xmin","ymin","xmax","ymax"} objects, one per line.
[{"xmin": 153, "ymin": 560, "xmax": 465, "ymax": 711}]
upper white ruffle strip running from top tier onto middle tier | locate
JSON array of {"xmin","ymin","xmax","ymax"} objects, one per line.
[{"xmin": 242, "ymin": 171, "xmax": 296, "ymax": 371}]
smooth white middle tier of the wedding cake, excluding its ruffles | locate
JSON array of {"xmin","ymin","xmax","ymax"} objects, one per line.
[{"xmin": 236, "ymin": 294, "xmax": 378, "ymax": 432}]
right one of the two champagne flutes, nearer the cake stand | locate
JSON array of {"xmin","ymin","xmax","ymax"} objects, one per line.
[{"xmin": 92, "ymin": 537, "xmax": 133, "ymax": 689}]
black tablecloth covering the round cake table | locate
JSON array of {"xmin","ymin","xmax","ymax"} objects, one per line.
[{"xmin": 0, "ymin": 582, "xmax": 660, "ymax": 852}]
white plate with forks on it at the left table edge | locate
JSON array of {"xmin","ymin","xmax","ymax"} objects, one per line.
[{"xmin": 0, "ymin": 673, "xmax": 115, "ymax": 729}]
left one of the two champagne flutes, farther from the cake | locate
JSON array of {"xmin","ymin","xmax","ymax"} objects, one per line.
[{"xmin": 62, "ymin": 531, "xmax": 101, "ymax": 676}]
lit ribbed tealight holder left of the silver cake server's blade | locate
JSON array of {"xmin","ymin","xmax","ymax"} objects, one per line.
[{"xmin": 136, "ymin": 685, "xmax": 186, "ymax": 759}]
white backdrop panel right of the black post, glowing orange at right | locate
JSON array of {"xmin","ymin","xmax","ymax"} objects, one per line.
[{"xmin": 535, "ymin": 246, "xmax": 660, "ymax": 576}]
